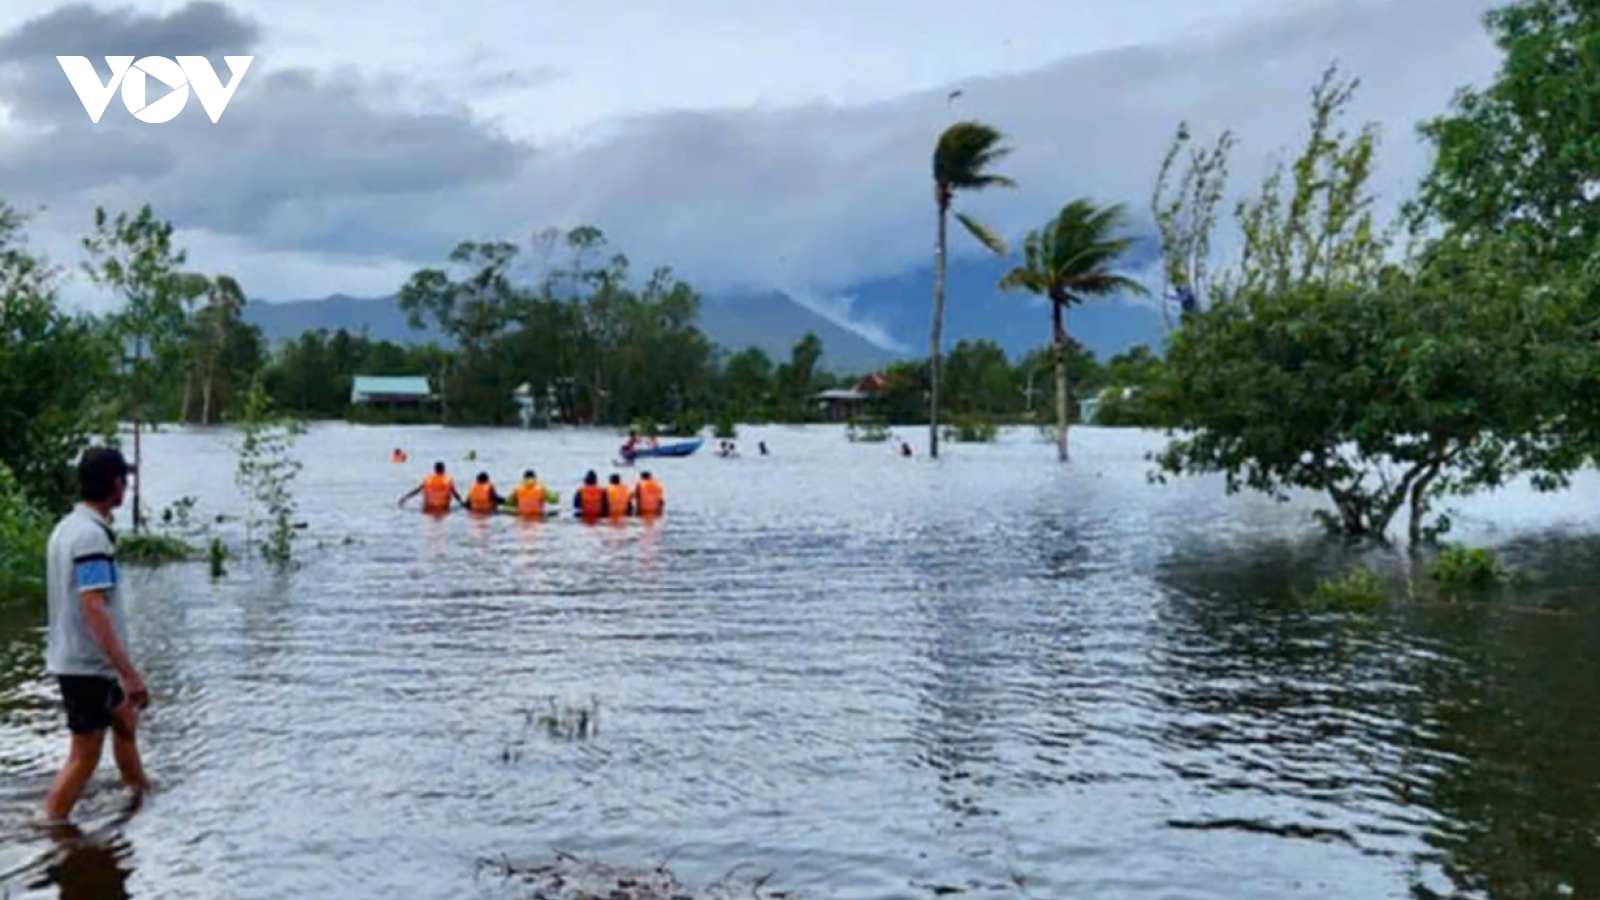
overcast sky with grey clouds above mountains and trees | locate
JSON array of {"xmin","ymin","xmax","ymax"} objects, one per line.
[{"xmin": 0, "ymin": 0, "xmax": 1496, "ymax": 329}]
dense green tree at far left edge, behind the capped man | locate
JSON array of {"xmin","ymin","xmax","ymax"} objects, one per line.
[{"xmin": 0, "ymin": 203, "xmax": 117, "ymax": 511}]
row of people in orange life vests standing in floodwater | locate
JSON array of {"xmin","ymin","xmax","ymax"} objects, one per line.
[{"xmin": 400, "ymin": 463, "xmax": 667, "ymax": 522}]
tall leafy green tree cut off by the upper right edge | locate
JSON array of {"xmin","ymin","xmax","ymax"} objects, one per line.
[{"xmin": 1410, "ymin": 0, "xmax": 1600, "ymax": 458}]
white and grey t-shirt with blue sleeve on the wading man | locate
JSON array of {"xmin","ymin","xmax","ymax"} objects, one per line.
[{"xmin": 45, "ymin": 503, "xmax": 128, "ymax": 677}]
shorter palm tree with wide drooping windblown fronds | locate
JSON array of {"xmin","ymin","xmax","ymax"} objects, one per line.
[{"xmin": 1000, "ymin": 200, "xmax": 1147, "ymax": 463}]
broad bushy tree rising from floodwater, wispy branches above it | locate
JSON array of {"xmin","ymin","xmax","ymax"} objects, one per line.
[{"xmin": 1157, "ymin": 70, "xmax": 1581, "ymax": 543}]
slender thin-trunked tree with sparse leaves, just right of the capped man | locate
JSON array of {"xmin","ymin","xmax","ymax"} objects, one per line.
[{"xmin": 83, "ymin": 205, "xmax": 205, "ymax": 532}]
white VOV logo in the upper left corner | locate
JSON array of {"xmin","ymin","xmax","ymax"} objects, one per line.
[{"xmin": 56, "ymin": 56, "xmax": 254, "ymax": 125}]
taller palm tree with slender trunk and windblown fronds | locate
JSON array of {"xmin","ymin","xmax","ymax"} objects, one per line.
[{"xmin": 928, "ymin": 122, "xmax": 1016, "ymax": 458}]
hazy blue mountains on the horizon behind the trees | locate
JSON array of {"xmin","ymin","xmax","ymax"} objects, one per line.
[{"xmin": 245, "ymin": 259, "xmax": 1162, "ymax": 372}]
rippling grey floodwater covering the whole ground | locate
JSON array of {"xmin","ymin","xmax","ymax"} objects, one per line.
[{"xmin": 0, "ymin": 426, "xmax": 1600, "ymax": 900}]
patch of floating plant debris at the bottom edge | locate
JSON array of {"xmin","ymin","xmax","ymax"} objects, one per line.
[{"xmin": 478, "ymin": 850, "xmax": 798, "ymax": 900}]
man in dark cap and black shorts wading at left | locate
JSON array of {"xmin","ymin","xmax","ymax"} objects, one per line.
[{"xmin": 45, "ymin": 448, "xmax": 150, "ymax": 822}]
